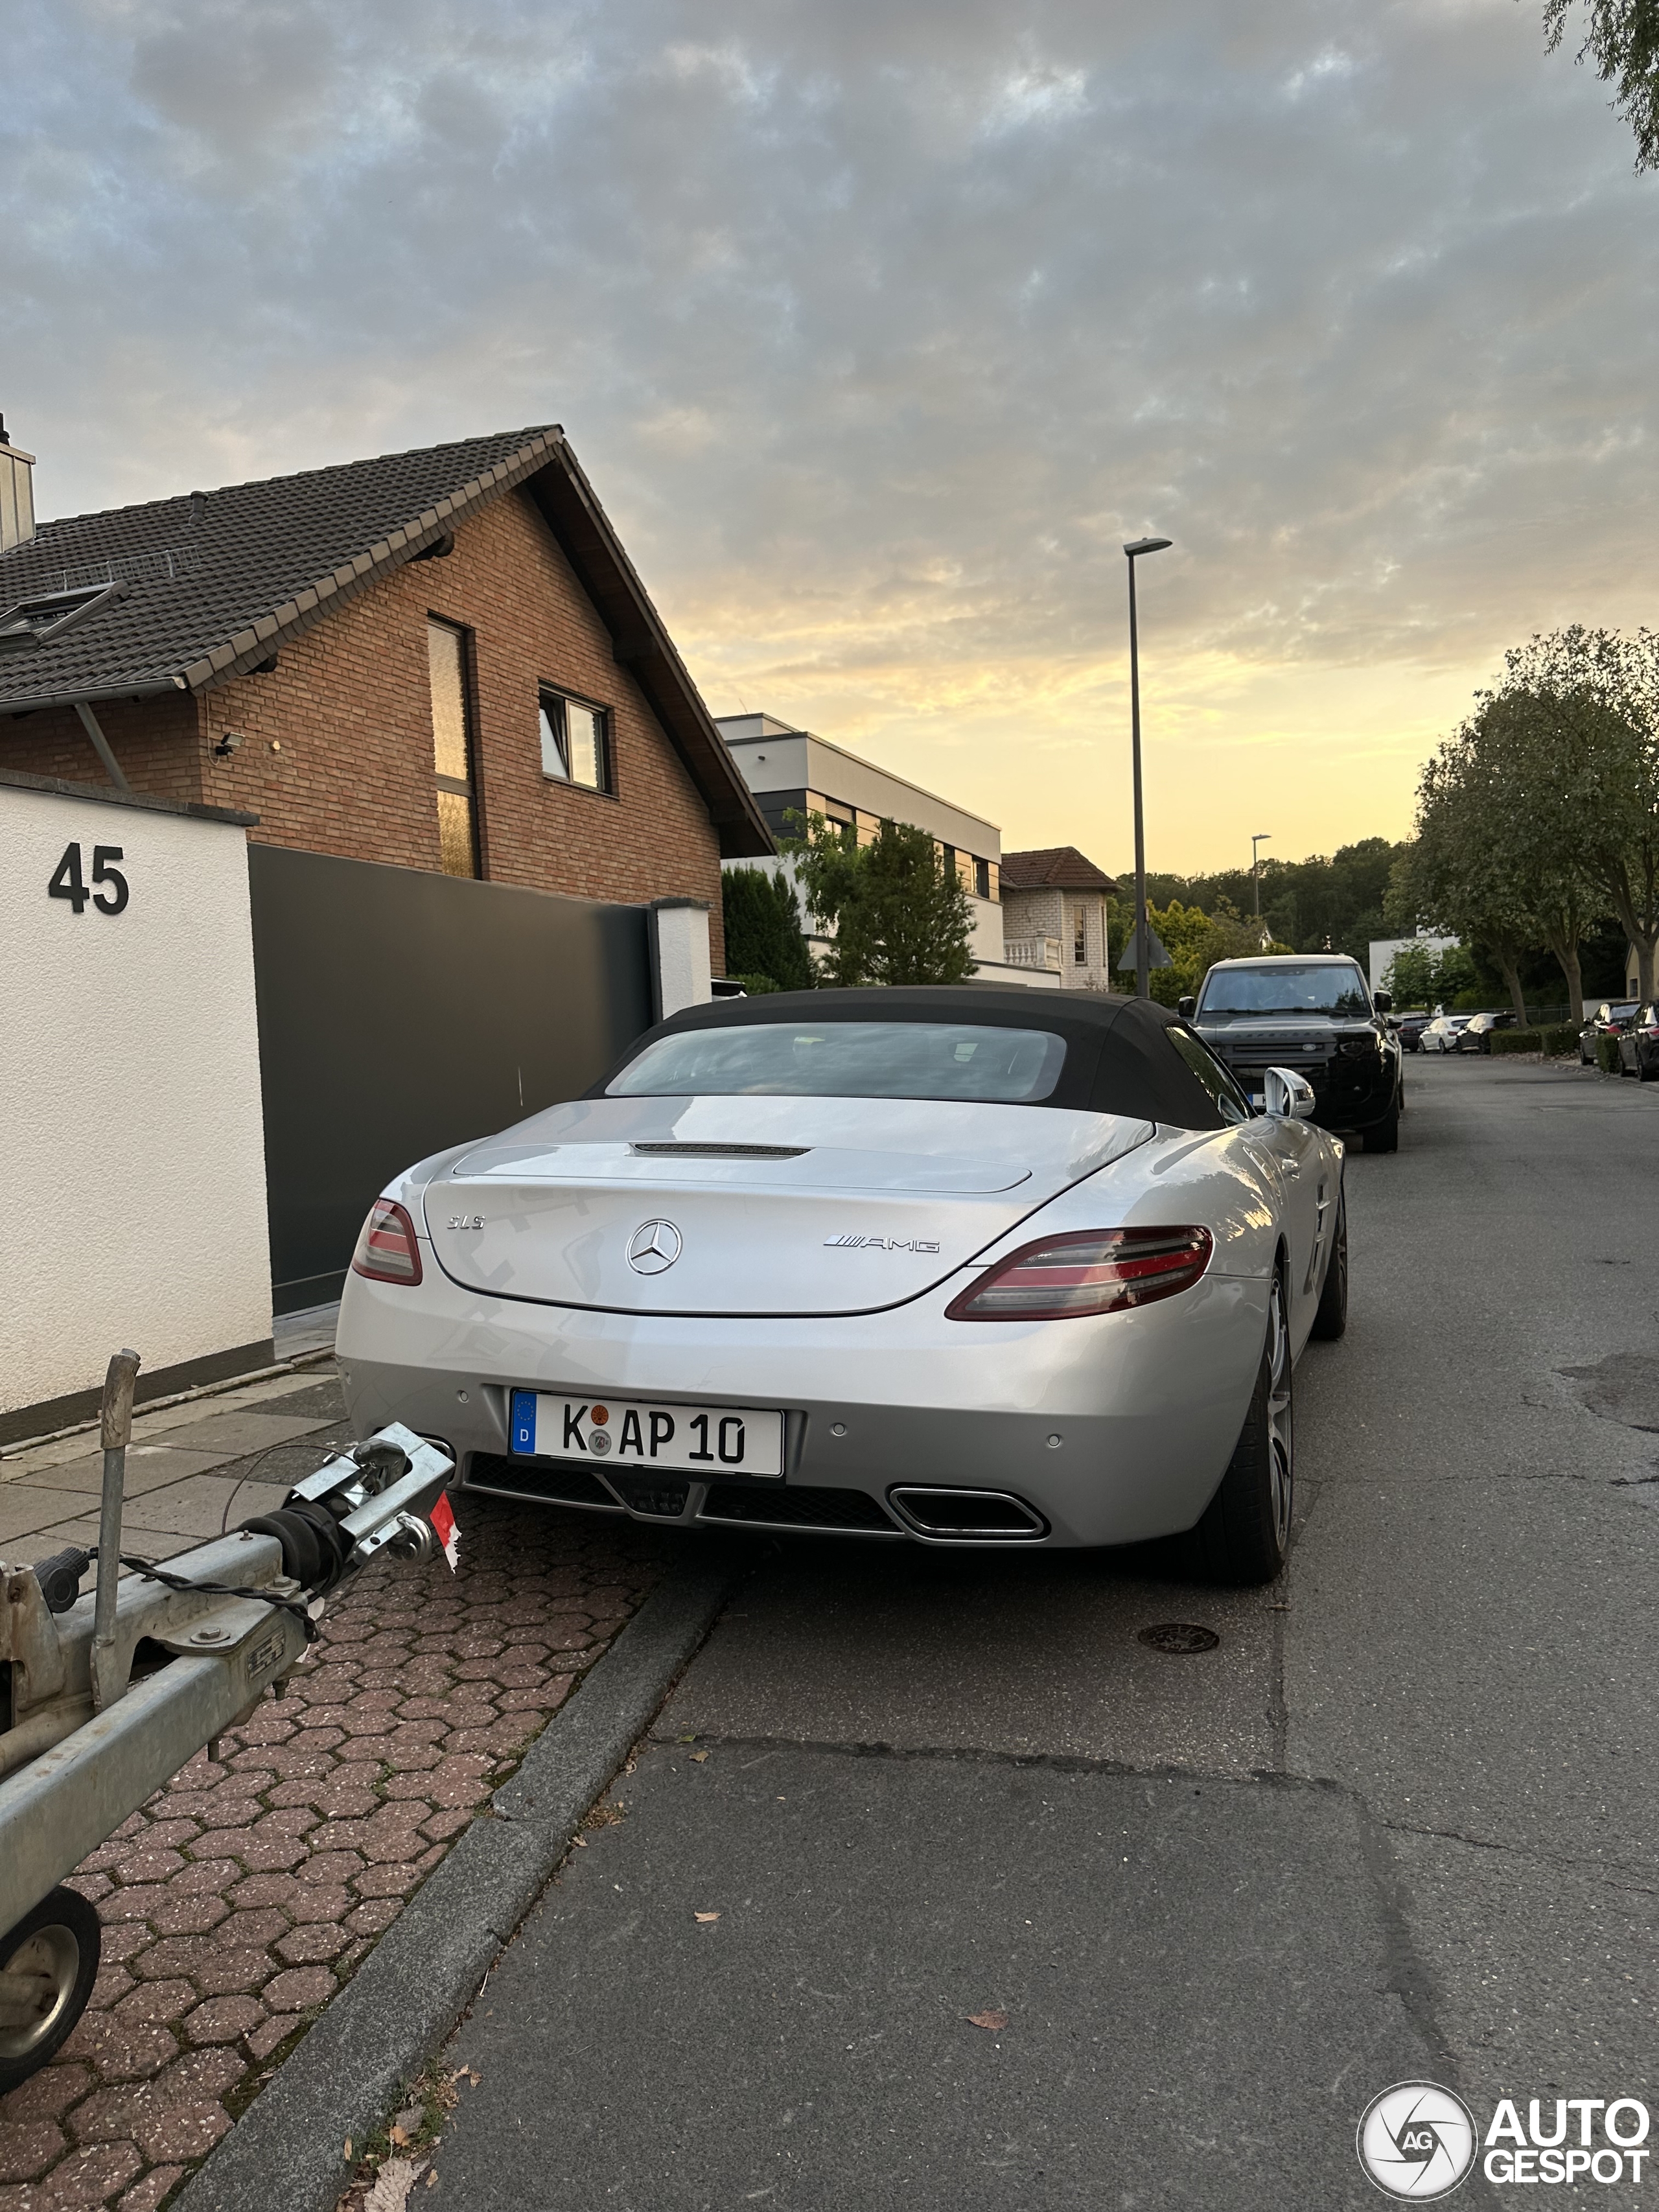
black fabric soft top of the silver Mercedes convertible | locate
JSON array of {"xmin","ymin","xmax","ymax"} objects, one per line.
[{"xmin": 606, "ymin": 984, "xmax": 1225, "ymax": 1128}]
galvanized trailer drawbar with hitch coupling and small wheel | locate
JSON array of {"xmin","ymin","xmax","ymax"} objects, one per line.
[{"xmin": 0, "ymin": 1351, "xmax": 454, "ymax": 2093}]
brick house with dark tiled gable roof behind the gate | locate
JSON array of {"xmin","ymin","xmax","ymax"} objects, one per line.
[{"xmin": 0, "ymin": 425, "xmax": 774, "ymax": 971}]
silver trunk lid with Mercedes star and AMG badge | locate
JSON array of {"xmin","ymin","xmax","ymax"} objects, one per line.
[{"xmin": 424, "ymin": 1097, "xmax": 1152, "ymax": 1314}]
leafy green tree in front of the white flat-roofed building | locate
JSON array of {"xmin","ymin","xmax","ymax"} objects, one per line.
[{"xmin": 781, "ymin": 814, "xmax": 973, "ymax": 986}]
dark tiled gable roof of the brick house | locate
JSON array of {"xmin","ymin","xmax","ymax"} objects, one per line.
[{"xmin": 0, "ymin": 423, "xmax": 774, "ymax": 858}]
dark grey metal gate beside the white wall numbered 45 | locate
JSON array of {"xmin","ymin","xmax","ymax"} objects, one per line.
[{"xmin": 249, "ymin": 845, "xmax": 653, "ymax": 1314}]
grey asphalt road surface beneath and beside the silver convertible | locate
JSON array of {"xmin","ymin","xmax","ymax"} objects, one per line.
[{"xmin": 431, "ymin": 1062, "xmax": 1659, "ymax": 2212}]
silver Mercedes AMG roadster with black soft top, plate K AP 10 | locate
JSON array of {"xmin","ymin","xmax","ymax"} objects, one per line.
[{"xmin": 338, "ymin": 984, "xmax": 1347, "ymax": 1581}]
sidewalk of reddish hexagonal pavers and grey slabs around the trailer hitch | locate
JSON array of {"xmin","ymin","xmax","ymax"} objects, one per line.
[{"xmin": 0, "ymin": 1367, "xmax": 668, "ymax": 2212}]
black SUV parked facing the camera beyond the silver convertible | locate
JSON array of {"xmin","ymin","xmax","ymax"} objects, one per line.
[{"xmin": 1179, "ymin": 953, "xmax": 1402, "ymax": 1152}]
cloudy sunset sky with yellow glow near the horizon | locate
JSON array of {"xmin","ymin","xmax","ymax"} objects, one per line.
[{"xmin": 0, "ymin": 0, "xmax": 1659, "ymax": 867}]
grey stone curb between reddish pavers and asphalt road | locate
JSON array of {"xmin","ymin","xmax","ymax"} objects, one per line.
[{"xmin": 172, "ymin": 1559, "xmax": 739, "ymax": 2212}]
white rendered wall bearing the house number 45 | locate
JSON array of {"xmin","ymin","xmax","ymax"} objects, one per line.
[{"xmin": 0, "ymin": 783, "xmax": 270, "ymax": 1414}]
